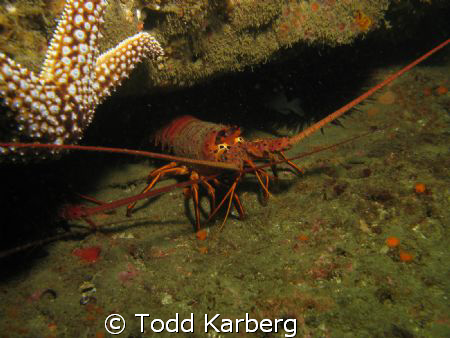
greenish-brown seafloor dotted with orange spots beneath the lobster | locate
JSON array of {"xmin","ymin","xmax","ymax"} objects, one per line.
[{"xmin": 0, "ymin": 46, "xmax": 450, "ymax": 337}]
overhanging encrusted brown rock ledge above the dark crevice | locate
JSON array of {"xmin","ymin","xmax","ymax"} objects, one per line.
[{"xmin": 0, "ymin": 0, "xmax": 446, "ymax": 93}]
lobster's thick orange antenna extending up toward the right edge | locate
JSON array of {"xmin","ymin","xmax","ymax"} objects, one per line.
[{"xmin": 289, "ymin": 39, "xmax": 450, "ymax": 145}]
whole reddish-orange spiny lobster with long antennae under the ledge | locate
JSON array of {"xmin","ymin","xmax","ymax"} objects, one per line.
[{"xmin": 0, "ymin": 39, "xmax": 450, "ymax": 230}]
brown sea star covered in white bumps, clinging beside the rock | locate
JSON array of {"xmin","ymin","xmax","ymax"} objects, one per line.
[{"xmin": 0, "ymin": 0, "xmax": 163, "ymax": 159}]
